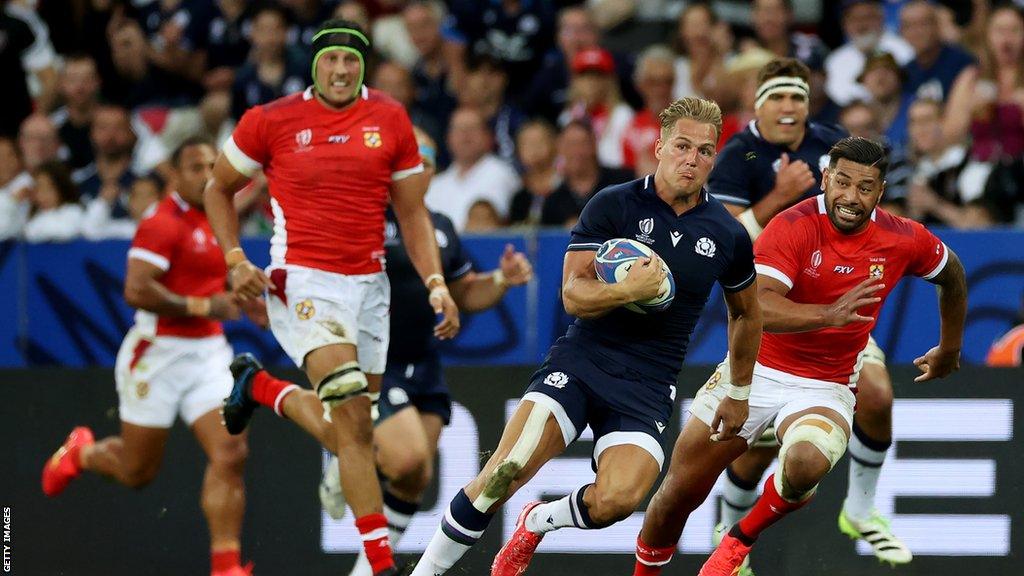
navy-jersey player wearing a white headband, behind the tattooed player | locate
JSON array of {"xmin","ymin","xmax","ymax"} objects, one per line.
[{"xmin": 708, "ymin": 58, "xmax": 912, "ymax": 565}]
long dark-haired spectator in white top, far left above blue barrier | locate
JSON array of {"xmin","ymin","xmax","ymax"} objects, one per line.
[{"xmin": 25, "ymin": 161, "xmax": 82, "ymax": 242}]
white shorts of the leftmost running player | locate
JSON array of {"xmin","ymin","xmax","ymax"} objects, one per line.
[{"xmin": 114, "ymin": 328, "xmax": 233, "ymax": 428}]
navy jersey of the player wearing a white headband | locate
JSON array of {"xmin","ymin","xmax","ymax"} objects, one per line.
[{"xmin": 708, "ymin": 120, "xmax": 849, "ymax": 207}]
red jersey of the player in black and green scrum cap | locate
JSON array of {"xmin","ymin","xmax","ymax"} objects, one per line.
[{"xmin": 224, "ymin": 86, "xmax": 423, "ymax": 275}]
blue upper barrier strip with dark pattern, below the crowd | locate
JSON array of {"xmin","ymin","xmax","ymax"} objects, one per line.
[{"xmin": 0, "ymin": 230, "xmax": 1024, "ymax": 367}]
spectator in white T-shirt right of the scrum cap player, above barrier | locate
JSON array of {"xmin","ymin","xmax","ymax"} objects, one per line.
[{"xmin": 426, "ymin": 108, "xmax": 520, "ymax": 232}]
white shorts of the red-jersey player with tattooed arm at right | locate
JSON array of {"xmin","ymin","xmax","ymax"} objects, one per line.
[{"xmin": 690, "ymin": 357, "xmax": 857, "ymax": 445}]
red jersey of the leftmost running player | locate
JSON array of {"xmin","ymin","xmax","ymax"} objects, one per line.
[{"xmin": 128, "ymin": 193, "xmax": 227, "ymax": 338}]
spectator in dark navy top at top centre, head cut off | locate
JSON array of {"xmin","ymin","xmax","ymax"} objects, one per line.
[{"xmin": 445, "ymin": 0, "xmax": 555, "ymax": 101}]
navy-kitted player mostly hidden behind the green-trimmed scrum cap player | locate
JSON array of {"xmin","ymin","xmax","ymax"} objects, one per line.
[{"xmin": 321, "ymin": 127, "xmax": 534, "ymax": 576}]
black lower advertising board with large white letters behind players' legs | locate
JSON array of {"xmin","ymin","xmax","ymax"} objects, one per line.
[{"xmin": 0, "ymin": 366, "xmax": 1024, "ymax": 576}]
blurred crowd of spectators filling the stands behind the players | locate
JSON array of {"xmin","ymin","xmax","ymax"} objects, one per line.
[{"xmin": 0, "ymin": 0, "xmax": 1024, "ymax": 242}]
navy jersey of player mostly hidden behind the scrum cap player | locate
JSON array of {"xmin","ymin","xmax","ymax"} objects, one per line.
[{"xmin": 384, "ymin": 207, "xmax": 473, "ymax": 365}]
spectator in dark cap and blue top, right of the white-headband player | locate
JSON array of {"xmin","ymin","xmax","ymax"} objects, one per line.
[{"xmin": 857, "ymin": 53, "xmax": 913, "ymax": 151}]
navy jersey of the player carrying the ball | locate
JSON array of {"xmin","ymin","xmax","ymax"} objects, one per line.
[{"xmin": 555, "ymin": 176, "xmax": 755, "ymax": 384}]
